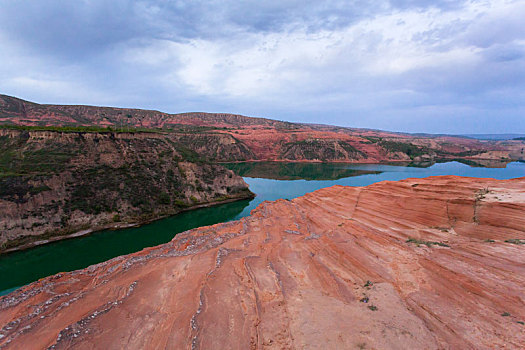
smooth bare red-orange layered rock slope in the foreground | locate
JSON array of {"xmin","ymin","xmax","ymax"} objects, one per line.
[{"xmin": 0, "ymin": 176, "xmax": 525, "ymax": 349}]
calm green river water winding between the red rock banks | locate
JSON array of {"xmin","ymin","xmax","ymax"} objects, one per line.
[{"xmin": 0, "ymin": 162, "xmax": 525, "ymax": 295}]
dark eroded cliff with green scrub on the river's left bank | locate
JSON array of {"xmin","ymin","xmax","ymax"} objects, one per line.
[{"xmin": 0, "ymin": 129, "xmax": 252, "ymax": 252}]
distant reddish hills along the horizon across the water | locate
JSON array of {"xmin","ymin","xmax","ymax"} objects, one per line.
[{"xmin": 0, "ymin": 95, "xmax": 525, "ymax": 163}]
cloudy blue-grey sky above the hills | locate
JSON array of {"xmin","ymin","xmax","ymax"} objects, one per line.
[{"xmin": 0, "ymin": 0, "xmax": 525, "ymax": 133}]
